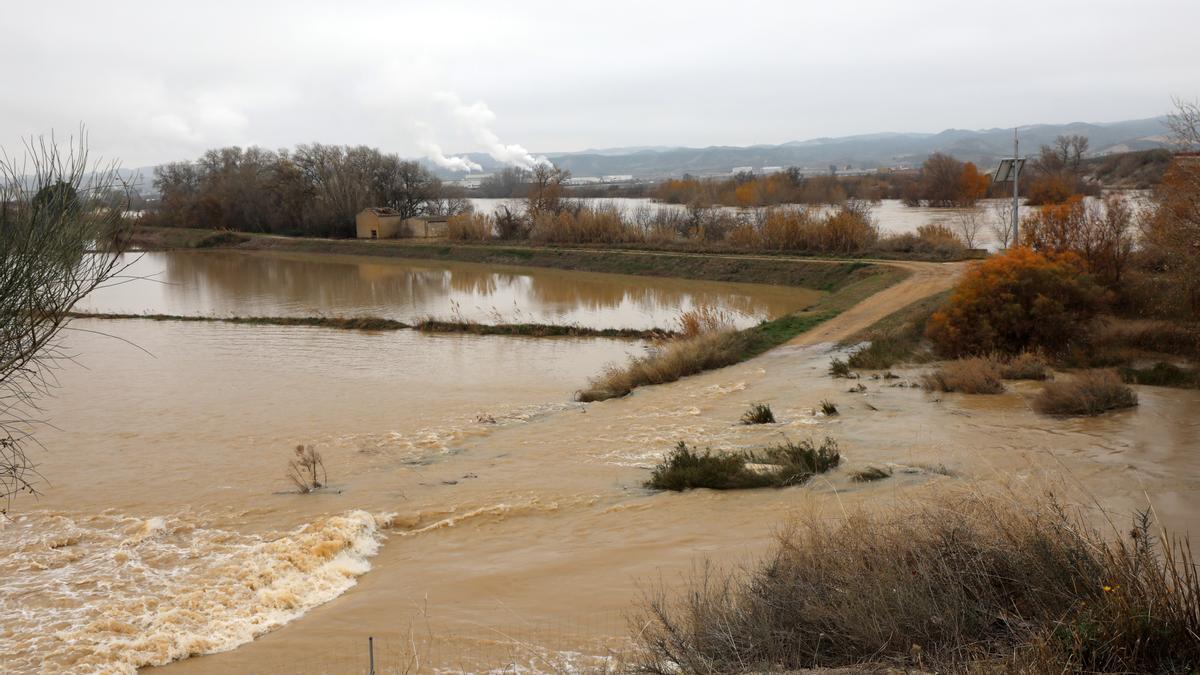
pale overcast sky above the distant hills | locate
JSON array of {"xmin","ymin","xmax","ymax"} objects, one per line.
[{"xmin": 0, "ymin": 0, "xmax": 1200, "ymax": 167}]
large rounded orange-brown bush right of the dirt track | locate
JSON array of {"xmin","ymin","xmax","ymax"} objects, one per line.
[{"xmin": 925, "ymin": 247, "xmax": 1102, "ymax": 357}]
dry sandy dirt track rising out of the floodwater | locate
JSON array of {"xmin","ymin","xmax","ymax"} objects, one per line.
[{"xmin": 788, "ymin": 261, "xmax": 971, "ymax": 345}]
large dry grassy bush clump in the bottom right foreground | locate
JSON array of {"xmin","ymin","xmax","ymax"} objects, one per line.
[{"xmin": 635, "ymin": 495, "xmax": 1200, "ymax": 674}]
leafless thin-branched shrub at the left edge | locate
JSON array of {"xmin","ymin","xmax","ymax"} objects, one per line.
[{"xmin": 0, "ymin": 133, "xmax": 130, "ymax": 510}]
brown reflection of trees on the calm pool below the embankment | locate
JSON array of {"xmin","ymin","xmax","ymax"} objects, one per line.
[{"xmin": 162, "ymin": 251, "xmax": 796, "ymax": 318}]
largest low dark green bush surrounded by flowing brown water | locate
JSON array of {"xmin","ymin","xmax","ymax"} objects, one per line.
[{"xmin": 646, "ymin": 438, "xmax": 841, "ymax": 491}]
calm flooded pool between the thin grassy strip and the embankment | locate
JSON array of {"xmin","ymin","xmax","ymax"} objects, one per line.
[{"xmin": 84, "ymin": 251, "xmax": 820, "ymax": 328}]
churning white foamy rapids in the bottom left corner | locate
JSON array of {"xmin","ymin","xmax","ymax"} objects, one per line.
[{"xmin": 0, "ymin": 510, "xmax": 386, "ymax": 673}]
